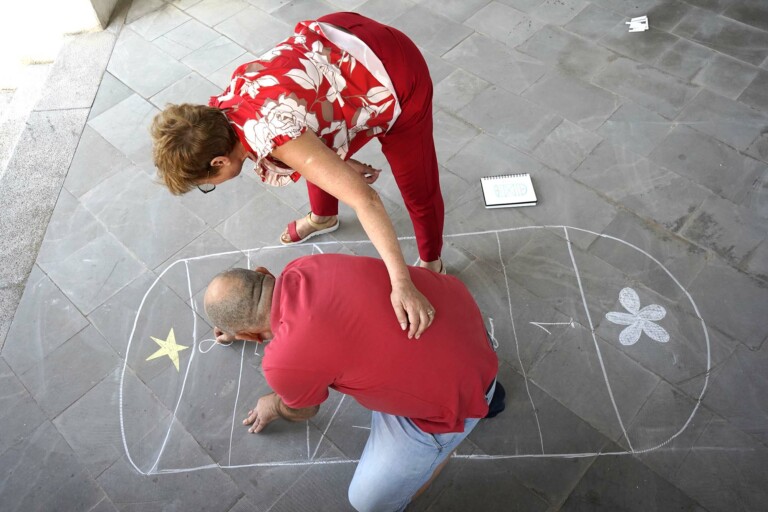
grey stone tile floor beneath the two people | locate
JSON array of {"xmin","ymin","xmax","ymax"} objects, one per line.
[{"xmin": 0, "ymin": 0, "xmax": 768, "ymax": 512}]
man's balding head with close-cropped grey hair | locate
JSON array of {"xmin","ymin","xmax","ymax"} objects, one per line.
[{"xmin": 205, "ymin": 268, "xmax": 275, "ymax": 335}]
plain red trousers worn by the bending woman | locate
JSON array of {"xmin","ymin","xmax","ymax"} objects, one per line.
[{"xmin": 307, "ymin": 12, "xmax": 444, "ymax": 261}]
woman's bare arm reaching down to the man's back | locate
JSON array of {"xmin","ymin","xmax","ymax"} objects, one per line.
[{"xmin": 272, "ymin": 131, "xmax": 434, "ymax": 338}]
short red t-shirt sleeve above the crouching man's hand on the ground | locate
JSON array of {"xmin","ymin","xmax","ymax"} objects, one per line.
[{"xmin": 264, "ymin": 368, "xmax": 333, "ymax": 409}]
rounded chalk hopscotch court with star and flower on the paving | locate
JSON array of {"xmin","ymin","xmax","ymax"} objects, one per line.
[{"xmin": 119, "ymin": 226, "xmax": 711, "ymax": 474}]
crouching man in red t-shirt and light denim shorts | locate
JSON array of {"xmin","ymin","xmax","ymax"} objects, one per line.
[{"xmin": 205, "ymin": 254, "xmax": 504, "ymax": 512}]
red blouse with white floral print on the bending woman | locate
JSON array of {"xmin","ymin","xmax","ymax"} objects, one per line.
[{"xmin": 209, "ymin": 21, "xmax": 397, "ymax": 185}]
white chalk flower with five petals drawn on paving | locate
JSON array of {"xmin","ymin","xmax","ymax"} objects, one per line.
[{"xmin": 605, "ymin": 288, "xmax": 669, "ymax": 345}]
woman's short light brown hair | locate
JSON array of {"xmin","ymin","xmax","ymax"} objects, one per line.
[{"xmin": 151, "ymin": 103, "xmax": 237, "ymax": 195}]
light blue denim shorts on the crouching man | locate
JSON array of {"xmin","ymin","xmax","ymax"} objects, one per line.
[{"xmin": 349, "ymin": 380, "xmax": 496, "ymax": 512}]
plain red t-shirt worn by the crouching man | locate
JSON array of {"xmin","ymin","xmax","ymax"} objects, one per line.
[{"xmin": 262, "ymin": 254, "xmax": 498, "ymax": 434}]
